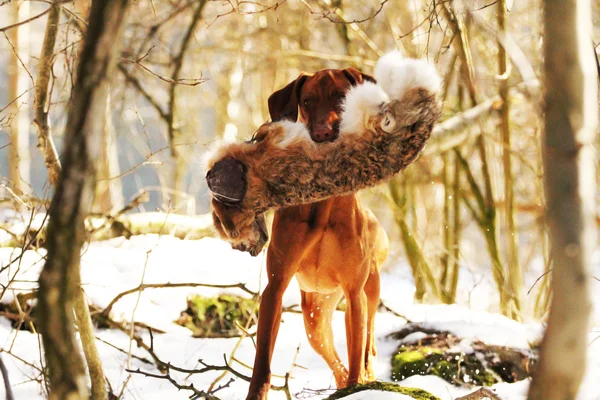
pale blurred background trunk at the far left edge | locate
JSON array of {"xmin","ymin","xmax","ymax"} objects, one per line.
[{"xmin": 7, "ymin": 1, "xmax": 31, "ymax": 198}]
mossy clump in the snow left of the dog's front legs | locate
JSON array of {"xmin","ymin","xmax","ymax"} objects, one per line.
[{"xmin": 176, "ymin": 294, "xmax": 258, "ymax": 337}]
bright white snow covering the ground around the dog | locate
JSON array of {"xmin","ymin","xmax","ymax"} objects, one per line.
[{"xmin": 0, "ymin": 235, "xmax": 600, "ymax": 400}]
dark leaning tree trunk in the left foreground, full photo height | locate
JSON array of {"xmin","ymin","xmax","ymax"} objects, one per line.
[{"xmin": 38, "ymin": 0, "xmax": 128, "ymax": 400}]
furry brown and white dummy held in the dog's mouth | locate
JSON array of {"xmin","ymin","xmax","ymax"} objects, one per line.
[{"xmin": 207, "ymin": 53, "xmax": 441, "ymax": 255}]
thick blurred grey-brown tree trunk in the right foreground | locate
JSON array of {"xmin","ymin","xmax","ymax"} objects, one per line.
[{"xmin": 529, "ymin": 0, "xmax": 598, "ymax": 400}]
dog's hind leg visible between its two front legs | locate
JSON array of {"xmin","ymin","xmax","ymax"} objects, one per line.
[{"xmin": 301, "ymin": 289, "xmax": 348, "ymax": 388}]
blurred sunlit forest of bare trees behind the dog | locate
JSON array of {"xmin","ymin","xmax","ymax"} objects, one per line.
[{"xmin": 0, "ymin": 0, "xmax": 600, "ymax": 319}]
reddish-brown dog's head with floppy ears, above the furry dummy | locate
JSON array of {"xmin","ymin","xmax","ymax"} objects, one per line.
[{"xmin": 269, "ymin": 68, "xmax": 375, "ymax": 142}]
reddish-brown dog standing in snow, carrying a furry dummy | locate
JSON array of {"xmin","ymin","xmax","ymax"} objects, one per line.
[{"xmin": 247, "ymin": 68, "xmax": 388, "ymax": 400}]
